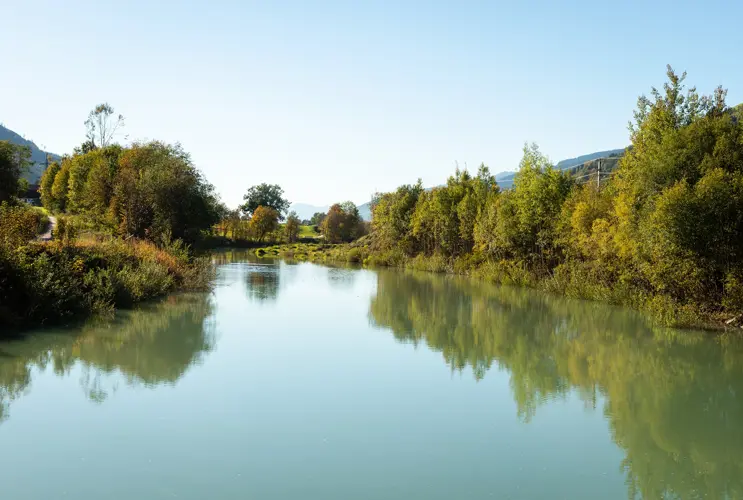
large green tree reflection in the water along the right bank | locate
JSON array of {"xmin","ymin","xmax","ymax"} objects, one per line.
[{"xmin": 370, "ymin": 272, "xmax": 743, "ymax": 499}]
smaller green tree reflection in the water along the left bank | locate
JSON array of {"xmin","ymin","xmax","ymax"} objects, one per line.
[{"xmin": 0, "ymin": 295, "xmax": 215, "ymax": 420}]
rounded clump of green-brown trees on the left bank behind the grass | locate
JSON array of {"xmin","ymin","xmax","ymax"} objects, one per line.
[{"xmin": 42, "ymin": 142, "xmax": 223, "ymax": 242}]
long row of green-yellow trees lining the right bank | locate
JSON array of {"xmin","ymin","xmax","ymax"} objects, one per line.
[{"xmin": 342, "ymin": 67, "xmax": 743, "ymax": 324}]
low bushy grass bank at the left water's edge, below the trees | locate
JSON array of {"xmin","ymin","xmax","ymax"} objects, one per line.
[{"xmin": 0, "ymin": 238, "xmax": 214, "ymax": 332}]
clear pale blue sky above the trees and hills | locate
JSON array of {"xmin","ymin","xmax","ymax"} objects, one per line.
[{"xmin": 0, "ymin": 0, "xmax": 743, "ymax": 206}]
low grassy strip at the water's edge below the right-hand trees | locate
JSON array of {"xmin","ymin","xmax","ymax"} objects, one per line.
[{"xmin": 256, "ymin": 239, "xmax": 743, "ymax": 332}]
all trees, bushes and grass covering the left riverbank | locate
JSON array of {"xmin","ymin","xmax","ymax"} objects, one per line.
[{"xmin": 0, "ymin": 105, "xmax": 219, "ymax": 331}]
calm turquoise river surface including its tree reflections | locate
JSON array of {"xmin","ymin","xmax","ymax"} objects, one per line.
[{"xmin": 0, "ymin": 253, "xmax": 743, "ymax": 500}]
